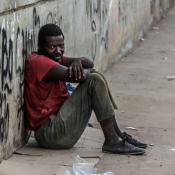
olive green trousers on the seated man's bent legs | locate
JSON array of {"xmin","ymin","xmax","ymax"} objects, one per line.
[{"xmin": 35, "ymin": 72, "xmax": 117, "ymax": 149}]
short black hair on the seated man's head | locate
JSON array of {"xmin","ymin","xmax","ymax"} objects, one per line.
[{"xmin": 38, "ymin": 24, "xmax": 64, "ymax": 47}]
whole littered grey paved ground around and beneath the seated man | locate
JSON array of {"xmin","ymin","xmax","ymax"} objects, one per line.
[{"xmin": 0, "ymin": 5, "xmax": 175, "ymax": 175}]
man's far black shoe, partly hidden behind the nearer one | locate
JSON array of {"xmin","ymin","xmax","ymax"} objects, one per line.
[{"xmin": 122, "ymin": 132, "xmax": 147, "ymax": 149}]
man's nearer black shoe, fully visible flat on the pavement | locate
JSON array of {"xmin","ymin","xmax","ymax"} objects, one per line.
[{"xmin": 102, "ymin": 140, "xmax": 145, "ymax": 155}]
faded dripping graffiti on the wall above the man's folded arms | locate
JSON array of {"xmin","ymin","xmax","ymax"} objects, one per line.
[{"xmin": 86, "ymin": 0, "xmax": 109, "ymax": 60}]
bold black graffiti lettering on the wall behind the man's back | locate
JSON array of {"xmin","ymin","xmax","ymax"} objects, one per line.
[{"xmin": 0, "ymin": 8, "xmax": 55, "ymax": 144}]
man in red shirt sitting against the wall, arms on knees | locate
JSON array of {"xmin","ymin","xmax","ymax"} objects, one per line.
[{"xmin": 25, "ymin": 24, "xmax": 147, "ymax": 155}]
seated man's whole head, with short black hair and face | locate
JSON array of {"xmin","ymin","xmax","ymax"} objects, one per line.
[{"xmin": 38, "ymin": 24, "xmax": 64, "ymax": 60}]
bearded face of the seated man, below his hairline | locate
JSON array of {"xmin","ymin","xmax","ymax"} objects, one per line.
[{"xmin": 44, "ymin": 35, "xmax": 64, "ymax": 60}]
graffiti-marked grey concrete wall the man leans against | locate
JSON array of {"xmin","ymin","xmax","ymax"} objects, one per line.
[{"xmin": 0, "ymin": 0, "xmax": 172, "ymax": 160}]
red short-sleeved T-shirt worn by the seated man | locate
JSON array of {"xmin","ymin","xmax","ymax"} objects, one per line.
[{"xmin": 24, "ymin": 53, "xmax": 69, "ymax": 130}]
